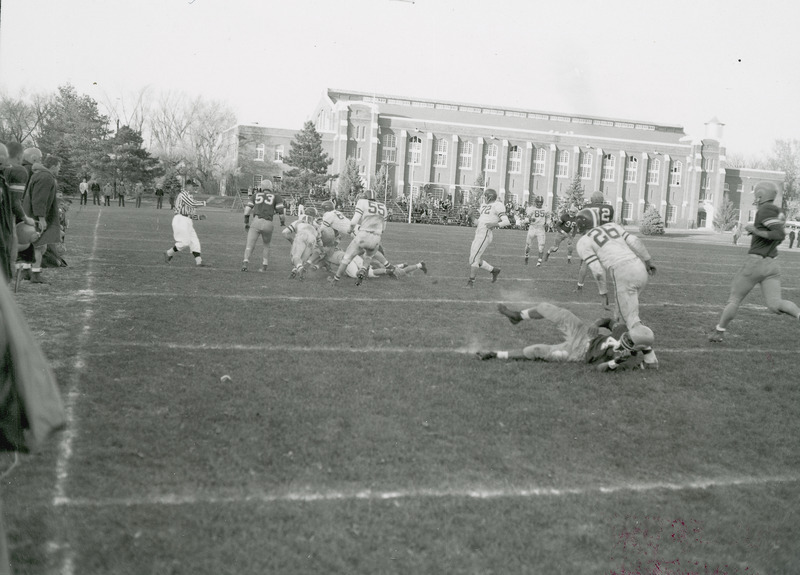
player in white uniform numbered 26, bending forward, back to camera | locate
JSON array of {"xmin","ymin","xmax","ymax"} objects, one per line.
[{"xmin": 576, "ymin": 209, "xmax": 658, "ymax": 369}]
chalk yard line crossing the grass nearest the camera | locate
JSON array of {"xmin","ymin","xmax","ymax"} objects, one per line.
[{"xmin": 53, "ymin": 476, "xmax": 800, "ymax": 507}]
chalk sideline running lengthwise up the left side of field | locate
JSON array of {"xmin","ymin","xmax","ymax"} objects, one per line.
[{"xmin": 47, "ymin": 211, "xmax": 103, "ymax": 575}]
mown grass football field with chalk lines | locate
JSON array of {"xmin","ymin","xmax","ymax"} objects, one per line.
[{"xmin": 2, "ymin": 205, "xmax": 800, "ymax": 575}]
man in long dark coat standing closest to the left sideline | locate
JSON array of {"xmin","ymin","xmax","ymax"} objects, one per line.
[{"xmin": 23, "ymin": 156, "xmax": 61, "ymax": 283}]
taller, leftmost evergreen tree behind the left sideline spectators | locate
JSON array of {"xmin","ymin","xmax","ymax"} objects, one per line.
[{"xmin": 37, "ymin": 84, "xmax": 109, "ymax": 194}]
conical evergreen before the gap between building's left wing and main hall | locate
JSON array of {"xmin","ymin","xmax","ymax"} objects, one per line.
[{"xmin": 283, "ymin": 121, "xmax": 334, "ymax": 196}]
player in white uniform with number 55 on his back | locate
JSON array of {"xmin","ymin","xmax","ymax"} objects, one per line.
[{"xmin": 328, "ymin": 190, "xmax": 391, "ymax": 285}]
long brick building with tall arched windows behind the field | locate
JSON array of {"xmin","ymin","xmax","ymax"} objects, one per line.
[{"xmin": 219, "ymin": 90, "xmax": 784, "ymax": 228}]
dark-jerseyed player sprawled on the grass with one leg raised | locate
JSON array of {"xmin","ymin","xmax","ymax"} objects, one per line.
[{"xmin": 477, "ymin": 303, "xmax": 652, "ymax": 371}]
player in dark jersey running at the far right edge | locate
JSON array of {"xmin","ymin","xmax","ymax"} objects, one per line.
[{"xmin": 708, "ymin": 182, "xmax": 800, "ymax": 342}]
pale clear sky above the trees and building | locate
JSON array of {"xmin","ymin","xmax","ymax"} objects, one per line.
[{"xmin": 0, "ymin": 0, "xmax": 800, "ymax": 158}]
